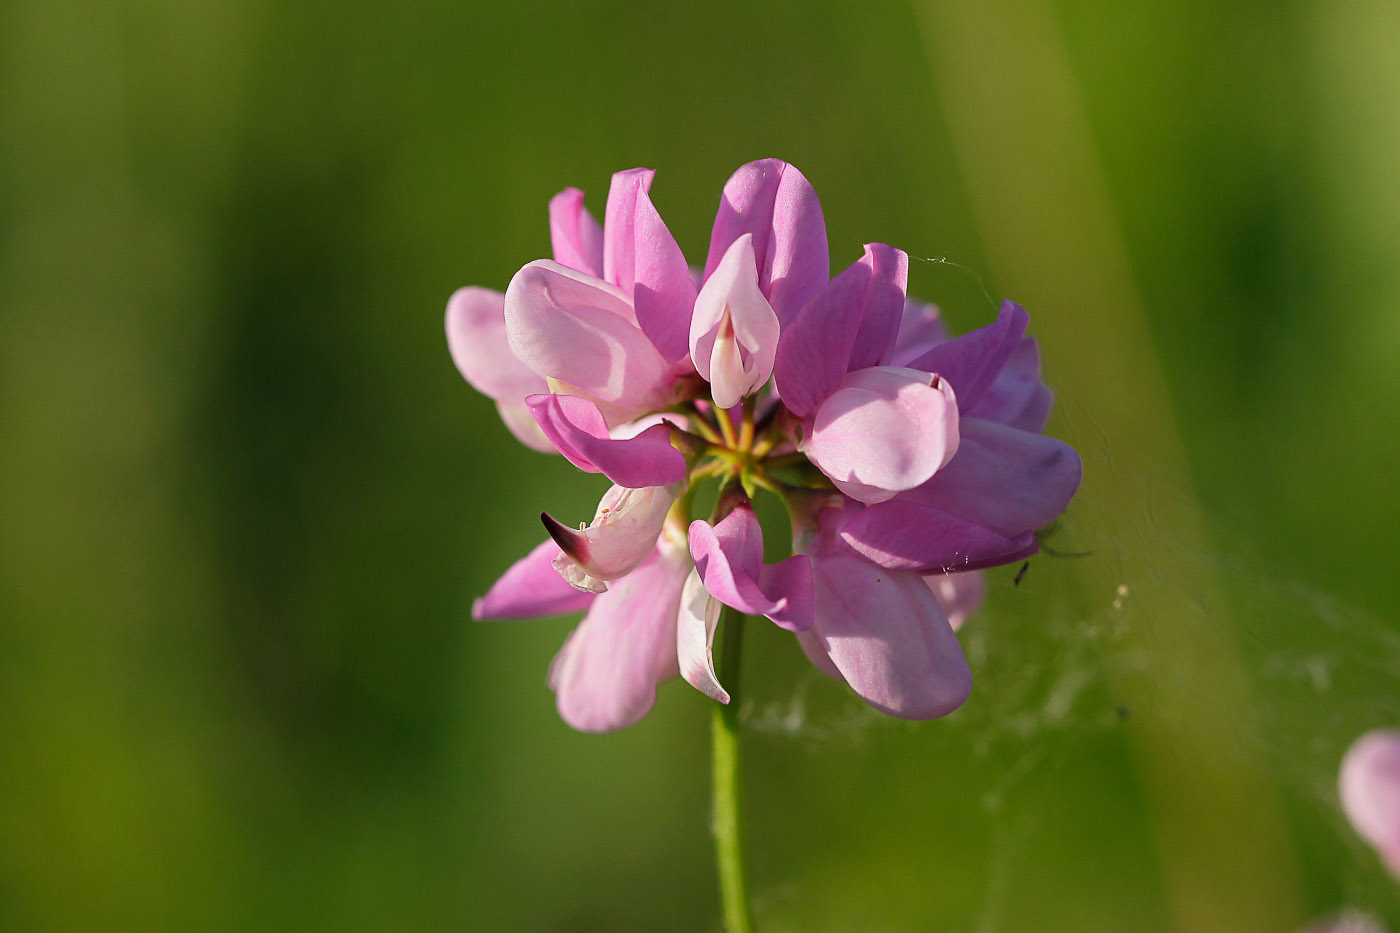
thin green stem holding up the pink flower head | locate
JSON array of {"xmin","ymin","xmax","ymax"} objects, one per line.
[{"xmin": 710, "ymin": 608, "xmax": 753, "ymax": 933}]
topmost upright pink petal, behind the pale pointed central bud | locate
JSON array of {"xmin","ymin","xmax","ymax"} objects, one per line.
[{"xmin": 704, "ymin": 158, "xmax": 830, "ymax": 321}]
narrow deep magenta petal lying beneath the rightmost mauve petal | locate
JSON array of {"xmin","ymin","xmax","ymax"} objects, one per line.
[{"xmin": 841, "ymin": 496, "xmax": 1036, "ymax": 573}]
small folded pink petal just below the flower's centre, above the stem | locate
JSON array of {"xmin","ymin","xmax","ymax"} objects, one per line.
[{"xmin": 690, "ymin": 506, "xmax": 812, "ymax": 632}]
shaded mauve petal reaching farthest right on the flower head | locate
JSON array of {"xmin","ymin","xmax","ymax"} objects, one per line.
[{"xmin": 900, "ymin": 417, "xmax": 1084, "ymax": 538}]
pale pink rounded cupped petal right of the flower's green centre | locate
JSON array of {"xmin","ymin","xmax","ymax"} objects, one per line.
[{"xmin": 802, "ymin": 366, "xmax": 958, "ymax": 502}]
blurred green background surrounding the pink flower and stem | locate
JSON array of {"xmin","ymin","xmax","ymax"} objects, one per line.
[{"xmin": 0, "ymin": 0, "xmax": 1400, "ymax": 933}]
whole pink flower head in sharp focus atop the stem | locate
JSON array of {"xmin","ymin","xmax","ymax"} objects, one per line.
[{"xmin": 447, "ymin": 158, "xmax": 1081, "ymax": 731}]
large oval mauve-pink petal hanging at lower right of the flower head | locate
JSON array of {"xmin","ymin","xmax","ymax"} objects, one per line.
[{"xmin": 812, "ymin": 555, "xmax": 972, "ymax": 719}]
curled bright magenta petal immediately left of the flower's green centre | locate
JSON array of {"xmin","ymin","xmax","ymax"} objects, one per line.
[{"xmin": 525, "ymin": 395, "xmax": 686, "ymax": 489}]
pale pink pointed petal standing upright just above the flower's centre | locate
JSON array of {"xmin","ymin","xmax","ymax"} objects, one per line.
[{"xmin": 690, "ymin": 234, "xmax": 778, "ymax": 408}]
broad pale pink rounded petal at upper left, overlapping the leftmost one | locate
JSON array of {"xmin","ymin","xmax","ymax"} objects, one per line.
[{"xmin": 505, "ymin": 259, "xmax": 672, "ymax": 415}]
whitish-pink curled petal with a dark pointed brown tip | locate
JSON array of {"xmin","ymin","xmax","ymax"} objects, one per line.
[{"xmin": 540, "ymin": 483, "xmax": 683, "ymax": 593}]
